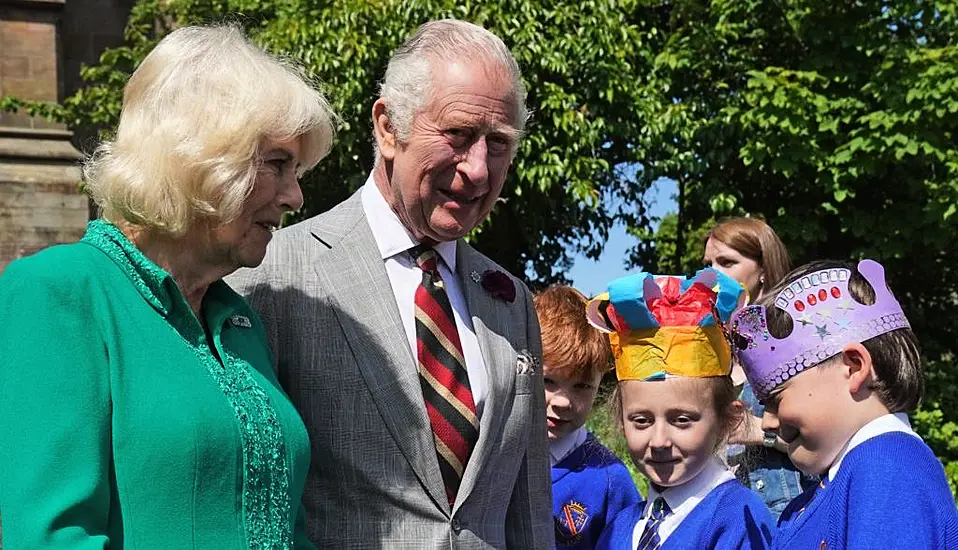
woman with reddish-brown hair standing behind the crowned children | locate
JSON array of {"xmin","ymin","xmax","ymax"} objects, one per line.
[{"xmin": 704, "ymin": 218, "xmax": 813, "ymax": 519}]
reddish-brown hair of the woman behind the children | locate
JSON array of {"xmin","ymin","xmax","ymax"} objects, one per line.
[{"xmin": 705, "ymin": 218, "xmax": 791, "ymax": 288}]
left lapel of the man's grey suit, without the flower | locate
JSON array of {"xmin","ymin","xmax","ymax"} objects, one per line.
[{"xmin": 310, "ymin": 193, "xmax": 448, "ymax": 511}]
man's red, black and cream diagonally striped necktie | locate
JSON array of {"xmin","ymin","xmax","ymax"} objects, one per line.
[{"xmin": 410, "ymin": 245, "xmax": 479, "ymax": 506}]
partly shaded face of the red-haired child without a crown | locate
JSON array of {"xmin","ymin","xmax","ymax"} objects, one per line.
[{"xmin": 542, "ymin": 367, "xmax": 602, "ymax": 441}]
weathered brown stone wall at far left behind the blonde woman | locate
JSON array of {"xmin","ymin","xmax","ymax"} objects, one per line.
[{"xmin": 0, "ymin": 0, "xmax": 89, "ymax": 271}]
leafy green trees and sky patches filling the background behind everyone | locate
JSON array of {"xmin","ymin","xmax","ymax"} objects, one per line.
[{"xmin": 0, "ymin": 0, "xmax": 958, "ymax": 498}]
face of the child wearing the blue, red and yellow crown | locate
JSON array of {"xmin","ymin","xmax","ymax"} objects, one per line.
[{"xmin": 619, "ymin": 378, "xmax": 723, "ymax": 487}]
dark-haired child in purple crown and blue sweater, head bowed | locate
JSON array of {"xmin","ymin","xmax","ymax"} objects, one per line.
[{"xmin": 728, "ymin": 260, "xmax": 958, "ymax": 549}]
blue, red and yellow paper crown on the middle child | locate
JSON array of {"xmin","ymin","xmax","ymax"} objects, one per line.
[{"xmin": 586, "ymin": 268, "xmax": 744, "ymax": 380}]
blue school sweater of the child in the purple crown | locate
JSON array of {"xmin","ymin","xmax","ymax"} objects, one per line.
[{"xmin": 773, "ymin": 432, "xmax": 958, "ymax": 550}]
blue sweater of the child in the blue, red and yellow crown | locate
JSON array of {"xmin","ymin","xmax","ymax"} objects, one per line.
[{"xmin": 596, "ymin": 479, "xmax": 776, "ymax": 550}]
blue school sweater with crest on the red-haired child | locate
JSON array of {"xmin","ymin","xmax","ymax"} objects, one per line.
[{"xmin": 552, "ymin": 434, "xmax": 641, "ymax": 550}]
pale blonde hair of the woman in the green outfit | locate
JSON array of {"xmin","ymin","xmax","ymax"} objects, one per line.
[{"xmin": 84, "ymin": 25, "xmax": 335, "ymax": 236}]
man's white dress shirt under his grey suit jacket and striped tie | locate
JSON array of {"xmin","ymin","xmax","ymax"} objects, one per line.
[{"xmin": 361, "ymin": 179, "xmax": 488, "ymax": 417}]
